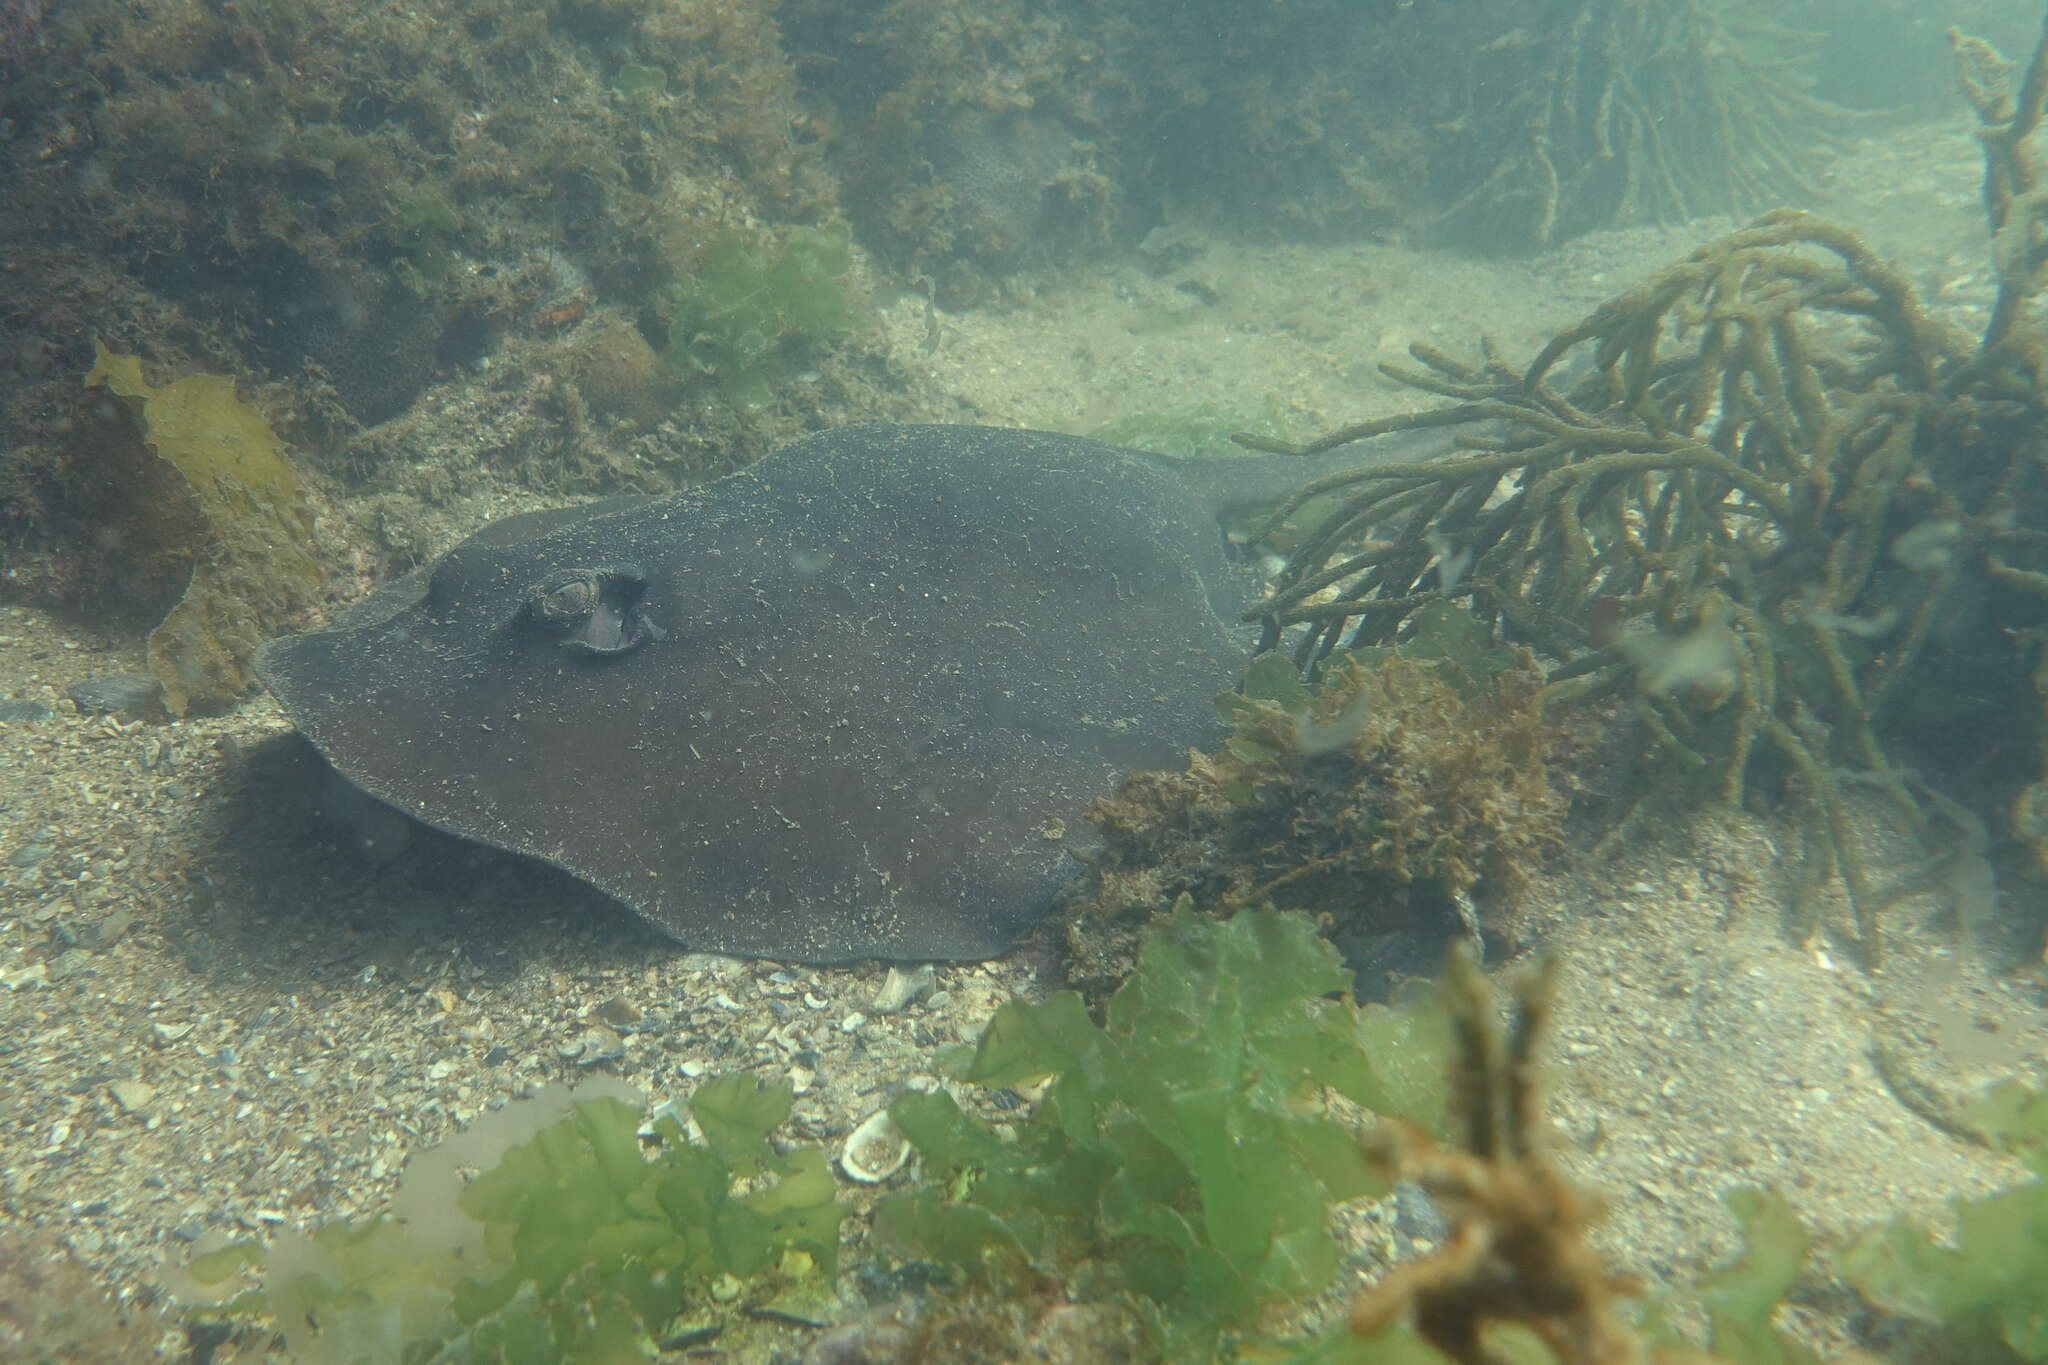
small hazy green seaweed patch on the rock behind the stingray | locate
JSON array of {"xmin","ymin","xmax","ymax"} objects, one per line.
[{"xmin": 668, "ymin": 227, "xmax": 858, "ymax": 411}]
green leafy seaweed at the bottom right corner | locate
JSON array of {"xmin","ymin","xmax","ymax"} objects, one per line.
[{"xmin": 1841, "ymin": 1083, "xmax": 2048, "ymax": 1361}]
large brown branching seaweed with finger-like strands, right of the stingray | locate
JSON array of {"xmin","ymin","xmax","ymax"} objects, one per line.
[{"xmin": 1247, "ymin": 192, "xmax": 2048, "ymax": 962}]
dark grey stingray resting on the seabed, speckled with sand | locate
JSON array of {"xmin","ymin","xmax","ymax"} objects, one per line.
[{"xmin": 258, "ymin": 426, "xmax": 1409, "ymax": 962}]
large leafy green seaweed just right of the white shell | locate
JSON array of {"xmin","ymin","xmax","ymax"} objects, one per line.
[{"xmin": 874, "ymin": 902, "xmax": 1450, "ymax": 1361}]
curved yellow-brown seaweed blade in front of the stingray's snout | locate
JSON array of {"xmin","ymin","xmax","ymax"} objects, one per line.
[{"xmin": 86, "ymin": 342, "xmax": 319, "ymax": 716}]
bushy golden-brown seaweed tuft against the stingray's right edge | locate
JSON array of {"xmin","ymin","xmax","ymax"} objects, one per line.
[{"xmin": 1067, "ymin": 604, "xmax": 1567, "ymax": 978}]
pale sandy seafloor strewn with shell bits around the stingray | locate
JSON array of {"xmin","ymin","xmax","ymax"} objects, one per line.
[{"xmin": 0, "ymin": 123, "xmax": 2048, "ymax": 1359}]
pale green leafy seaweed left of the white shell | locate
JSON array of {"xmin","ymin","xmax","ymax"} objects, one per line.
[{"xmin": 188, "ymin": 1076, "xmax": 842, "ymax": 1365}]
